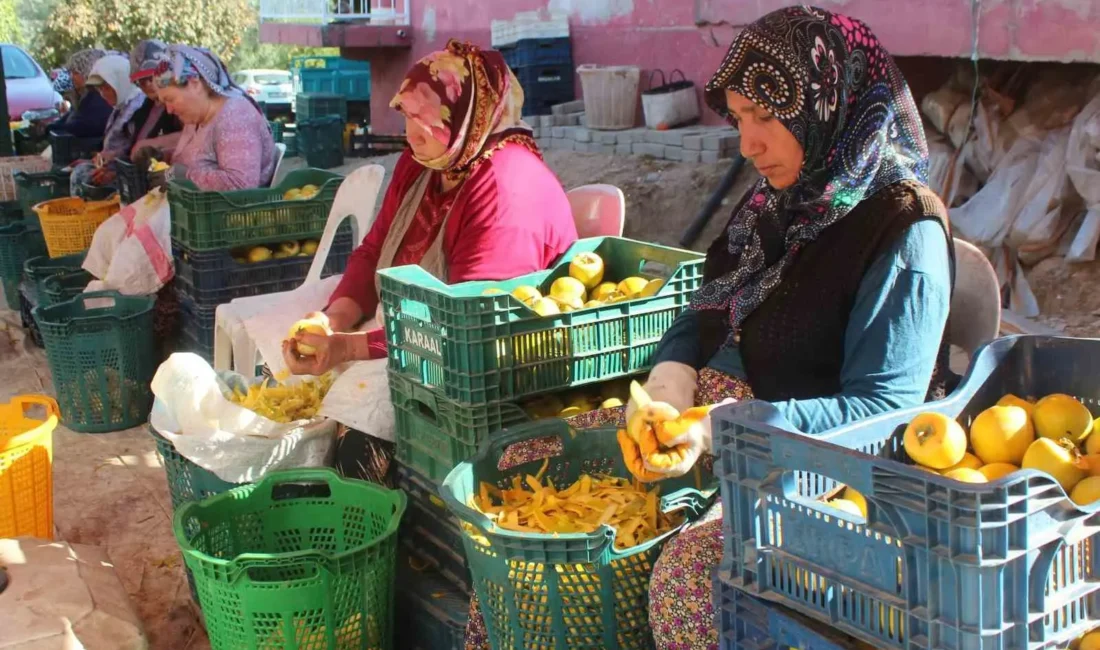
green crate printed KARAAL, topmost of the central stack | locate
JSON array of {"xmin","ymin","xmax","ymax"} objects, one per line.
[{"xmin": 378, "ymin": 236, "xmax": 703, "ymax": 404}]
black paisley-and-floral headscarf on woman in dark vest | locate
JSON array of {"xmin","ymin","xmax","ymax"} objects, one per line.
[{"xmin": 692, "ymin": 7, "xmax": 928, "ymax": 332}]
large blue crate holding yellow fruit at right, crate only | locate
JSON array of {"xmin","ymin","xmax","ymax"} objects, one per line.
[{"xmin": 714, "ymin": 337, "xmax": 1100, "ymax": 650}]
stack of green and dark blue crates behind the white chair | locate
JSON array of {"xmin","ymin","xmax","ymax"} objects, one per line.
[{"xmin": 168, "ymin": 169, "xmax": 352, "ymax": 361}]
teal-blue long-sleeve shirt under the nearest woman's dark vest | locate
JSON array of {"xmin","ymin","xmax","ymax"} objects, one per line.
[{"xmin": 653, "ymin": 220, "xmax": 952, "ymax": 433}]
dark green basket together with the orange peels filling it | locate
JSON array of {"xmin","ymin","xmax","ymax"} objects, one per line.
[{"xmin": 440, "ymin": 420, "xmax": 714, "ymax": 650}]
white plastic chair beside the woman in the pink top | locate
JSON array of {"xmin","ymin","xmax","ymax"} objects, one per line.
[{"xmin": 213, "ymin": 165, "xmax": 386, "ymax": 377}]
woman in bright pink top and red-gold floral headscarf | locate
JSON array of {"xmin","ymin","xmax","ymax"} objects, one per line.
[{"xmin": 284, "ymin": 41, "xmax": 576, "ymax": 481}]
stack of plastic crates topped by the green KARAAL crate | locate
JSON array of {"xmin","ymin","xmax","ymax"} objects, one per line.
[{"xmin": 380, "ymin": 238, "xmax": 702, "ymax": 647}]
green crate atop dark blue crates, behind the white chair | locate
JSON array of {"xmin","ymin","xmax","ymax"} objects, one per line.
[{"xmin": 168, "ymin": 169, "xmax": 343, "ymax": 251}]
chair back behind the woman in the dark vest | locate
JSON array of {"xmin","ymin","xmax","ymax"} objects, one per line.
[{"xmin": 947, "ymin": 239, "xmax": 1001, "ymax": 356}]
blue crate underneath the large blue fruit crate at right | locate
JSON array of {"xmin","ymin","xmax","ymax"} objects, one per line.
[{"xmin": 714, "ymin": 580, "xmax": 866, "ymax": 650}]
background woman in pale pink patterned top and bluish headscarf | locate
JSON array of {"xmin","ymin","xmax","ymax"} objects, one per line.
[{"xmin": 150, "ymin": 45, "xmax": 276, "ymax": 191}]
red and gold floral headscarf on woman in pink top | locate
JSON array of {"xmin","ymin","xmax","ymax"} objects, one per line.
[{"xmin": 389, "ymin": 40, "xmax": 538, "ymax": 179}]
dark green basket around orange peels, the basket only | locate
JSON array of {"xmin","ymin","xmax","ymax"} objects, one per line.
[{"xmin": 440, "ymin": 420, "xmax": 714, "ymax": 650}]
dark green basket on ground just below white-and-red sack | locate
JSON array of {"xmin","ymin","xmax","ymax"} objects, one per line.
[{"xmin": 33, "ymin": 291, "xmax": 157, "ymax": 433}]
